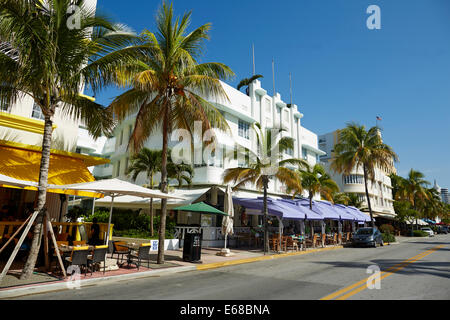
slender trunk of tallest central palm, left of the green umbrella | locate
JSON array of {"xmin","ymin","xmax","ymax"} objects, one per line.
[{"xmin": 157, "ymin": 108, "xmax": 169, "ymax": 264}]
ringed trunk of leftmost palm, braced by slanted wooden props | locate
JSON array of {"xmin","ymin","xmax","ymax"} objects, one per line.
[{"xmin": 20, "ymin": 116, "xmax": 53, "ymax": 280}]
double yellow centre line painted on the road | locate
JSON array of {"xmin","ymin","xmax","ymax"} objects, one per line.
[{"xmin": 320, "ymin": 245, "xmax": 444, "ymax": 300}]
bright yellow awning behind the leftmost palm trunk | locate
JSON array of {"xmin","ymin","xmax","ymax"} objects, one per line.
[{"xmin": 0, "ymin": 141, "xmax": 108, "ymax": 198}]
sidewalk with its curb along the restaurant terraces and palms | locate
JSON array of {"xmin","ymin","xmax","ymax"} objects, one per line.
[{"xmin": 0, "ymin": 246, "xmax": 343, "ymax": 299}]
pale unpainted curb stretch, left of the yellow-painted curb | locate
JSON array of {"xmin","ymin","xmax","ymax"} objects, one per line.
[{"xmin": 0, "ymin": 266, "xmax": 196, "ymax": 299}]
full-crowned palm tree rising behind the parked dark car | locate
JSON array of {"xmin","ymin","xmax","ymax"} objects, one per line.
[{"xmin": 331, "ymin": 123, "xmax": 398, "ymax": 227}]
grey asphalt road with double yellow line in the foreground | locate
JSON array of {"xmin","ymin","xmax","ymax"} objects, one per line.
[{"xmin": 12, "ymin": 235, "xmax": 450, "ymax": 300}]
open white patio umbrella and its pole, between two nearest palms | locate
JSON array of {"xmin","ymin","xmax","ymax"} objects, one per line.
[{"xmin": 54, "ymin": 179, "xmax": 184, "ymax": 245}]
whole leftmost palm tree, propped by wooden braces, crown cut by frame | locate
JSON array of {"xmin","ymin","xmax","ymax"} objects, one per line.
[{"xmin": 0, "ymin": 0, "xmax": 138, "ymax": 279}]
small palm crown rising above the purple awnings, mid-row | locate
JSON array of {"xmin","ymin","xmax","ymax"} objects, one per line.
[{"xmin": 293, "ymin": 164, "xmax": 339, "ymax": 210}]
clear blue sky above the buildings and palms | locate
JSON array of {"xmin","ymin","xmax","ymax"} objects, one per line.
[{"xmin": 91, "ymin": 0, "xmax": 450, "ymax": 187}]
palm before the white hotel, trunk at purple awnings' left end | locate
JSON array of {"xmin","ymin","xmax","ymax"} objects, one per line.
[{"xmin": 223, "ymin": 123, "xmax": 307, "ymax": 253}]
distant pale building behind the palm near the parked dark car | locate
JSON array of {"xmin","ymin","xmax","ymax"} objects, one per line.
[{"xmin": 319, "ymin": 130, "xmax": 396, "ymax": 220}]
